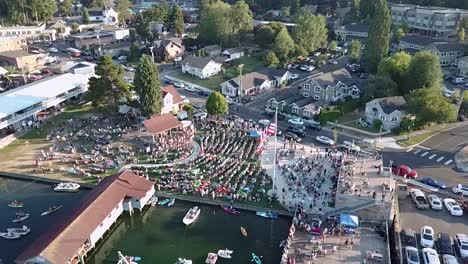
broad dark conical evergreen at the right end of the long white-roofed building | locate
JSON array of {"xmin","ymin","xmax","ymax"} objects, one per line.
[{"xmin": 86, "ymin": 55, "xmax": 130, "ymax": 106}]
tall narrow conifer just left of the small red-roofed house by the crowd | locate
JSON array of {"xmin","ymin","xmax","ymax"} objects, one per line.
[{"xmin": 133, "ymin": 54, "xmax": 163, "ymax": 118}]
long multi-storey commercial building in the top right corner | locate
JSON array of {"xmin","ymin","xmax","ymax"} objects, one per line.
[{"xmin": 389, "ymin": 3, "xmax": 468, "ymax": 37}]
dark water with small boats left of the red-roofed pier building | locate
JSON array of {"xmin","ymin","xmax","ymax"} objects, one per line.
[{"xmin": 0, "ymin": 178, "xmax": 87, "ymax": 264}]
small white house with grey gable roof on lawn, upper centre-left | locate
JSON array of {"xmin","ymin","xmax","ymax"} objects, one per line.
[{"xmin": 182, "ymin": 56, "xmax": 223, "ymax": 79}]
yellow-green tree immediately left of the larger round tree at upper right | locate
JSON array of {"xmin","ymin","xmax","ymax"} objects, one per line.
[{"xmin": 377, "ymin": 52, "xmax": 411, "ymax": 87}]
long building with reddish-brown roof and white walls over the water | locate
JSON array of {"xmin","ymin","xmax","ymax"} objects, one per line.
[{"xmin": 15, "ymin": 170, "xmax": 155, "ymax": 264}]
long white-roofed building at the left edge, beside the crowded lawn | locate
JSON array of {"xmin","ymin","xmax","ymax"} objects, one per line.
[{"xmin": 0, "ymin": 63, "xmax": 95, "ymax": 129}]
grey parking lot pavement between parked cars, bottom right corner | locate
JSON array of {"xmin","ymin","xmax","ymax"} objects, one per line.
[{"xmin": 398, "ymin": 192, "xmax": 468, "ymax": 263}]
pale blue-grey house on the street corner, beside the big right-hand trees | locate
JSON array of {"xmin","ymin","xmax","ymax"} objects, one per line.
[{"xmin": 364, "ymin": 96, "xmax": 407, "ymax": 130}]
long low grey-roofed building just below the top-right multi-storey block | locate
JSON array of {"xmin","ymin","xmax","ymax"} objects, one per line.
[{"xmin": 398, "ymin": 35, "xmax": 463, "ymax": 66}]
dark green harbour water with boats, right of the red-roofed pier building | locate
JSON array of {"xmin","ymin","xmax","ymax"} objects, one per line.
[{"xmin": 89, "ymin": 201, "xmax": 290, "ymax": 264}]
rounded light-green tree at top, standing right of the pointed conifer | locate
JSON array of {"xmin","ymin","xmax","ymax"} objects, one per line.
[{"xmin": 293, "ymin": 12, "xmax": 328, "ymax": 53}]
